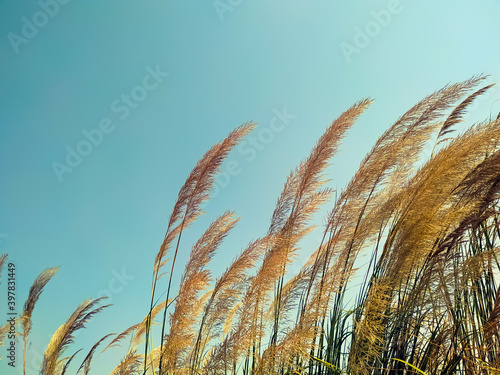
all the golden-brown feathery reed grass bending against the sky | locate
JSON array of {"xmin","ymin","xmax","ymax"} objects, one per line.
[{"xmin": 0, "ymin": 77, "xmax": 500, "ymax": 375}]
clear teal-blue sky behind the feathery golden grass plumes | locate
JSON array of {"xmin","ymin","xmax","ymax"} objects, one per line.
[{"xmin": 0, "ymin": 0, "xmax": 500, "ymax": 374}]
